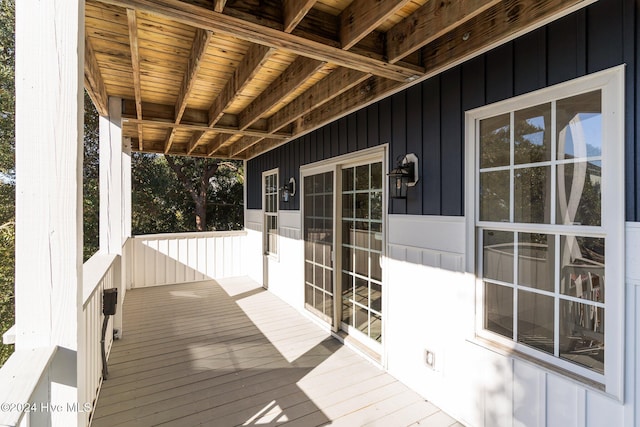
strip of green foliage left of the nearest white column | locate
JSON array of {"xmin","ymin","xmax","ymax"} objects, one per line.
[{"xmin": 0, "ymin": 0, "xmax": 15, "ymax": 366}]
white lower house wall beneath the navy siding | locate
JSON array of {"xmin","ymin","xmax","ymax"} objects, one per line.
[{"xmin": 246, "ymin": 206, "xmax": 640, "ymax": 427}]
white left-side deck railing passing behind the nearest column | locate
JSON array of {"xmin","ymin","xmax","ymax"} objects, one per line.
[{"xmin": 0, "ymin": 253, "xmax": 122, "ymax": 426}]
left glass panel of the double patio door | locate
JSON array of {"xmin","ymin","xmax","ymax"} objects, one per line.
[{"xmin": 303, "ymin": 172, "xmax": 334, "ymax": 324}]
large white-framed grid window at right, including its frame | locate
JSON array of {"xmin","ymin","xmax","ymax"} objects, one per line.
[{"xmin": 466, "ymin": 66, "xmax": 624, "ymax": 397}]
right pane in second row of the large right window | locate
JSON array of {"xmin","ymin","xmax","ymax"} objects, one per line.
[{"xmin": 557, "ymin": 161, "xmax": 602, "ymax": 226}]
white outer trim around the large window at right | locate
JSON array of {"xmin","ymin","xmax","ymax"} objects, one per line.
[{"xmin": 465, "ymin": 65, "xmax": 625, "ymax": 401}]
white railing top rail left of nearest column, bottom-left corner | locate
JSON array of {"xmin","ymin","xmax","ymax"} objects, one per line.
[{"xmin": 0, "ymin": 346, "xmax": 58, "ymax": 426}]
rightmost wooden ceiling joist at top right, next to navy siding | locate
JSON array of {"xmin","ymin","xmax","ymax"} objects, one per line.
[{"xmin": 423, "ymin": 0, "xmax": 594, "ymax": 74}]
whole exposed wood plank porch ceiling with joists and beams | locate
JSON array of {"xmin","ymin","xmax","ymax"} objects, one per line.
[{"xmin": 85, "ymin": 0, "xmax": 589, "ymax": 159}]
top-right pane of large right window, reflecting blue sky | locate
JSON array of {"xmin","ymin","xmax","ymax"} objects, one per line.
[{"xmin": 556, "ymin": 91, "xmax": 602, "ymax": 160}]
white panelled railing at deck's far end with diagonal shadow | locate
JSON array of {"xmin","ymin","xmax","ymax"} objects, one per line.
[{"xmin": 132, "ymin": 231, "xmax": 247, "ymax": 287}]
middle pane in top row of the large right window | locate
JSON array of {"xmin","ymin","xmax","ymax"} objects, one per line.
[{"xmin": 514, "ymin": 104, "xmax": 551, "ymax": 164}]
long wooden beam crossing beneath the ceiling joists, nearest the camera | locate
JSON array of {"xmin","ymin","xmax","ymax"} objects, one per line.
[{"xmin": 100, "ymin": 0, "xmax": 423, "ymax": 83}]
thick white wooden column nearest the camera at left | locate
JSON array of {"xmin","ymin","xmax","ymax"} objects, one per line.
[{"xmin": 16, "ymin": 0, "xmax": 84, "ymax": 426}]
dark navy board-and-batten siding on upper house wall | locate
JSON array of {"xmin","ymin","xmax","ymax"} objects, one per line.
[{"xmin": 247, "ymin": 0, "xmax": 640, "ymax": 221}]
